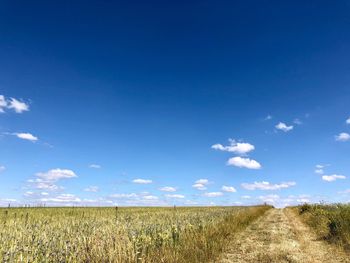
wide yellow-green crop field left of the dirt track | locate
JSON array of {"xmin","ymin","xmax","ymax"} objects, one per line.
[{"xmin": 0, "ymin": 206, "xmax": 271, "ymax": 263}]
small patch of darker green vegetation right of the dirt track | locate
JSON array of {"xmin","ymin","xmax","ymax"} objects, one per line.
[{"xmin": 297, "ymin": 204, "xmax": 350, "ymax": 252}]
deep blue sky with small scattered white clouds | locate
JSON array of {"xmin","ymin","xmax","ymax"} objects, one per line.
[{"xmin": 0, "ymin": 0, "xmax": 350, "ymax": 206}]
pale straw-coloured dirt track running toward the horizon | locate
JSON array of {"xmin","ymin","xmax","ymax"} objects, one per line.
[{"xmin": 216, "ymin": 209, "xmax": 350, "ymax": 263}]
